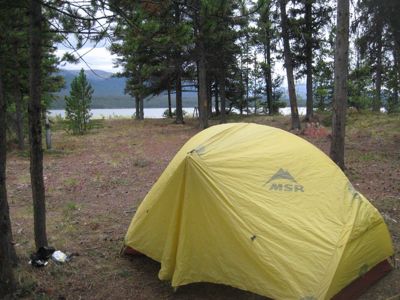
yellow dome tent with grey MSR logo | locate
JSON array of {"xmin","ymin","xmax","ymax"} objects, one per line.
[{"xmin": 125, "ymin": 123, "xmax": 393, "ymax": 299}]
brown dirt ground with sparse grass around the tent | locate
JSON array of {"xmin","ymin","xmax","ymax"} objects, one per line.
[{"xmin": 6, "ymin": 114, "xmax": 400, "ymax": 299}]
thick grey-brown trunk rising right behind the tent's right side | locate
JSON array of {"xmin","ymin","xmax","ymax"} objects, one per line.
[{"xmin": 330, "ymin": 0, "xmax": 349, "ymax": 170}]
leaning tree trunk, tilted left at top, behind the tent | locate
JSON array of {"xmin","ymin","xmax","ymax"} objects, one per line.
[{"xmin": 280, "ymin": 0, "xmax": 300, "ymax": 129}]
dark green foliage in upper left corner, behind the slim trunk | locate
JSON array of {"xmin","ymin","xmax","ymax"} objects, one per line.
[{"xmin": 0, "ymin": 0, "xmax": 64, "ymax": 144}]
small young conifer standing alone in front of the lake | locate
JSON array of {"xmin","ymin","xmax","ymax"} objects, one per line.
[{"xmin": 65, "ymin": 69, "xmax": 93, "ymax": 134}]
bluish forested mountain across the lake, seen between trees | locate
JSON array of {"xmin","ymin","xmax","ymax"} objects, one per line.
[{"xmin": 51, "ymin": 69, "xmax": 306, "ymax": 109}]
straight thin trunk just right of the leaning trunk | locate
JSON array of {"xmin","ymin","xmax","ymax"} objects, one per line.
[{"xmin": 305, "ymin": 0, "xmax": 314, "ymax": 121}]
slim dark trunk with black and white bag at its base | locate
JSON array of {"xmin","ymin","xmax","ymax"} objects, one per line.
[{"xmin": 29, "ymin": 0, "xmax": 47, "ymax": 248}]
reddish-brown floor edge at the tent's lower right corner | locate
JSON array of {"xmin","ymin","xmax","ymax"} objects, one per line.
[{"xmin": 332, "ymin": 259, "xmax": 393, "ymax": 300}]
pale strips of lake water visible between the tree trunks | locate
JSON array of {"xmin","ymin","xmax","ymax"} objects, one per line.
[{"xmin": 49, "ymin": 107, "xmax": 306, "ymax": 119}]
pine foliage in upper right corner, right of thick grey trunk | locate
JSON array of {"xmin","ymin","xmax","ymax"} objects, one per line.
[{"xmin": 350, "ymin": 0, "xmax": 400, "ymax": 113}]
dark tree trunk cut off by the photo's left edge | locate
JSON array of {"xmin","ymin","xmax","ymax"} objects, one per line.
[{"xmin": 0, "ymin": 62, "xmax": 16, "ymax": 296}]
